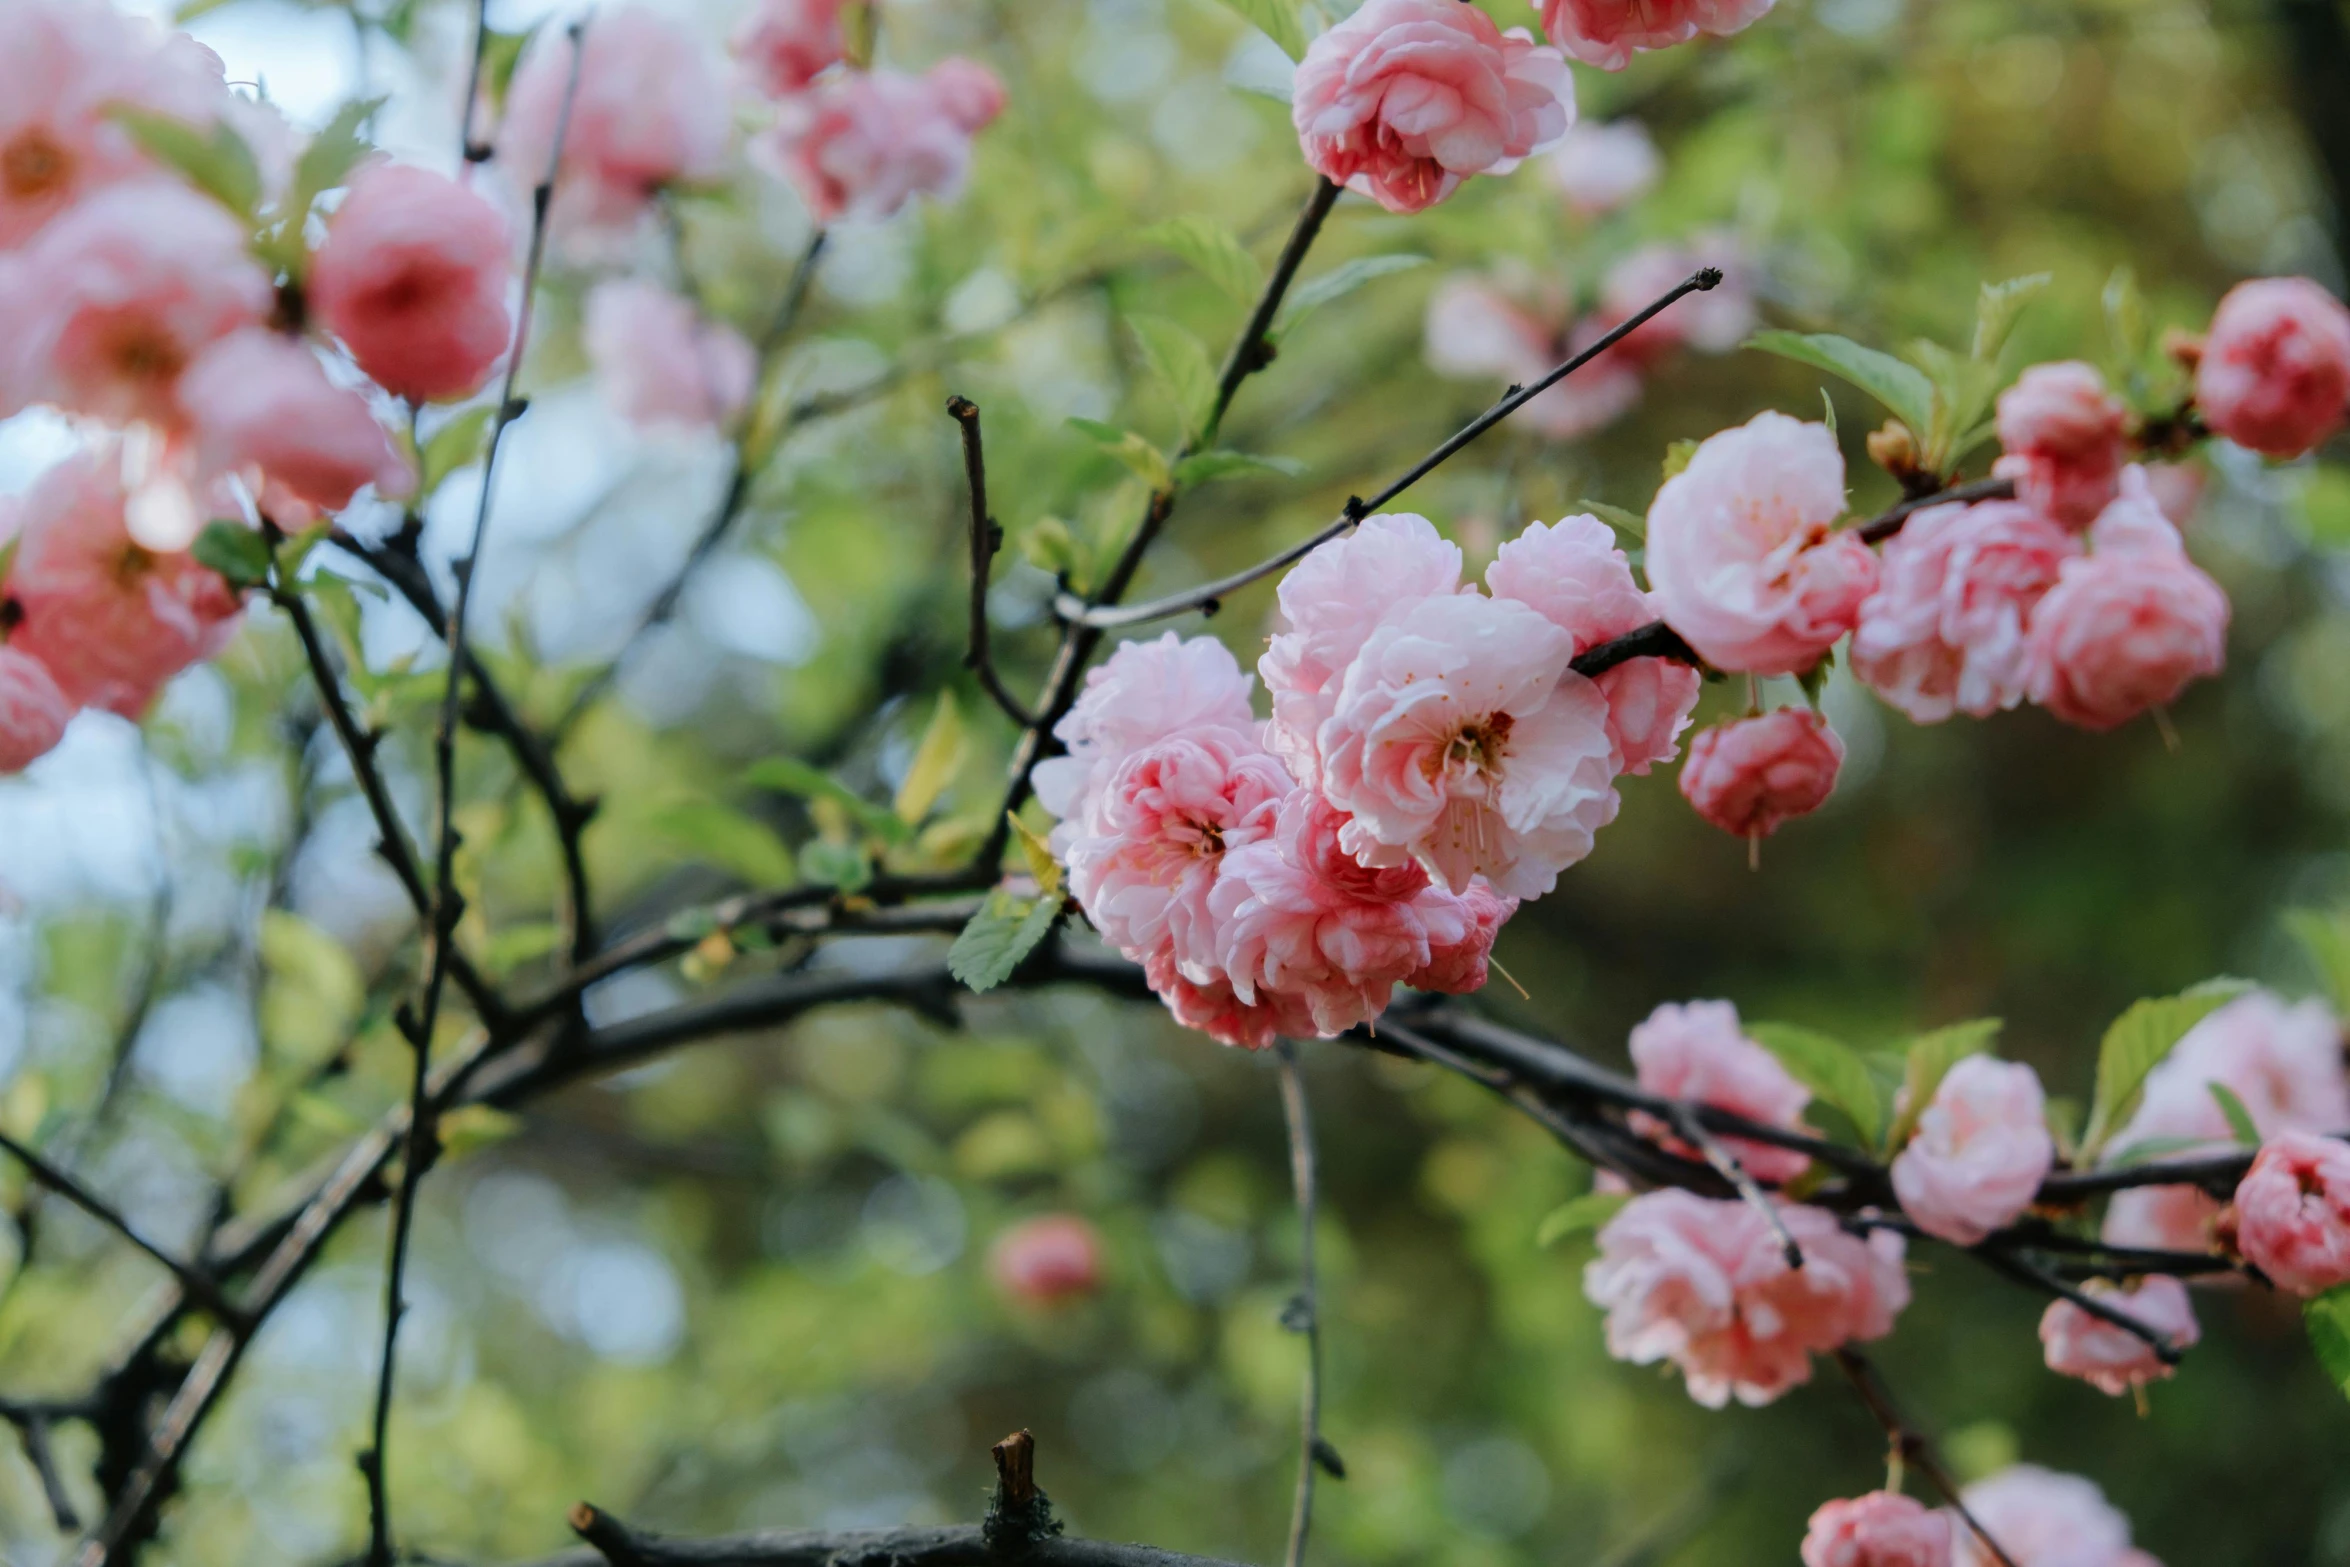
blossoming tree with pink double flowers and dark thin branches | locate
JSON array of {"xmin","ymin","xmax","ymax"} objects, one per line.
[{"xmin": 0, "ymin": 0, "xmax": 2350, "ymax": 1567}]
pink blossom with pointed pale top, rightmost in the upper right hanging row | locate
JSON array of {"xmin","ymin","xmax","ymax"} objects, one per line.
[{"xmin": 2030, "ymin": 481, "xmax": 2228, "ymax": 731}]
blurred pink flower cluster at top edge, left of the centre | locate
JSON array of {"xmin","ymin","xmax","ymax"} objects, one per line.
[{"xmin": 733, "ymin": 0, "xmax": 1003, "ymax": 223}]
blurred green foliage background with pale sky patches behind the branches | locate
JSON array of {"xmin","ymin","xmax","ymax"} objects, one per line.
[{"xmin": 0, "ymin": 0, "xmax": 2350, "ymax": 1567}]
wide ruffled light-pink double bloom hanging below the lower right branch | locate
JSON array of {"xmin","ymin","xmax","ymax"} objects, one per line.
[{"xmin": 1584, "ymin": 1189, "xmax": 1908, "ymax": 1410}]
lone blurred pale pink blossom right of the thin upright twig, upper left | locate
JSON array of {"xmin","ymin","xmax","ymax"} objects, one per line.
[{"xmin": 585, "ymin": 277, "xmax": 759, "ymax": 428}]
